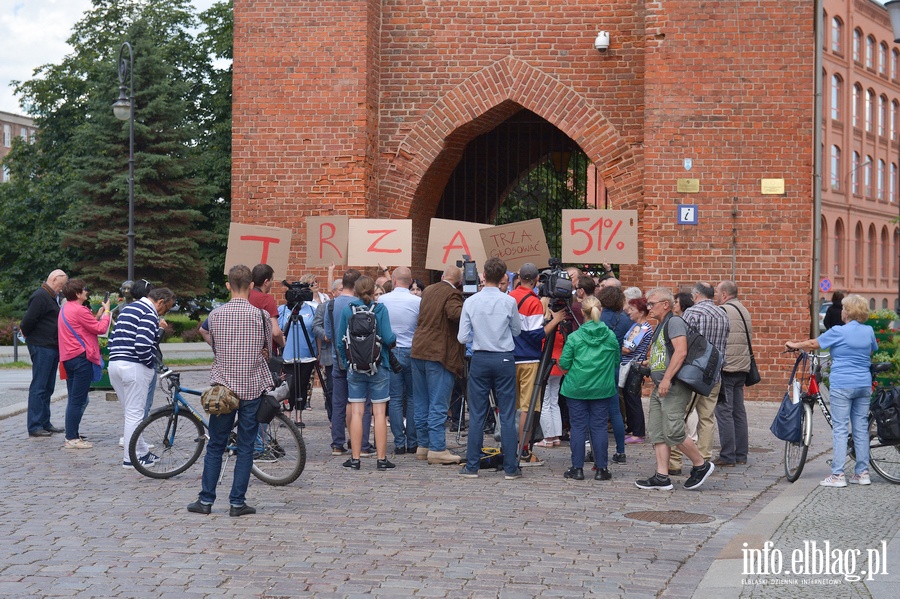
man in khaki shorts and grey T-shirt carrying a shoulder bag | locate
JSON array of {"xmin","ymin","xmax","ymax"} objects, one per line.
[{"xmin": 635, "ymin": 287, "xmax": 715, "ymax": 490}]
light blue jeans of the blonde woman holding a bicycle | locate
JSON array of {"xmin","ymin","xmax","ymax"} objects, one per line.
[{"xmin": 831, "ymin": 387, "xmax": 872, "ymax": 474}]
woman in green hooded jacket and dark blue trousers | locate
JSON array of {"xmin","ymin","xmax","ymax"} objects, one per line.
[{"xmin": 559, "ymin": 295, "xmax": 619, "ymax": 480}]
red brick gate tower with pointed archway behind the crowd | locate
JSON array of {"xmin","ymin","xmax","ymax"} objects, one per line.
[{"xmin": 232, "ymin": 0, "xmax": 814, "ymax": 398}]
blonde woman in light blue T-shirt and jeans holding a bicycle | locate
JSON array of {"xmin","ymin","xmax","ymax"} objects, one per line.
[{"xmin": 784, "ymin": 294, "xmax": 878, "ymax": 487}]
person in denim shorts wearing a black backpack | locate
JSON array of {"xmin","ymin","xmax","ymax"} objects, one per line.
[{"xmin": 336, "ymin": 276, "xmax": 397, "ymax": 470}]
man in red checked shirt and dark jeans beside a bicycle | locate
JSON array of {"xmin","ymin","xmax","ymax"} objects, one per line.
[{"xmin": 188, "ymin": 265, "xmax": 272, "ymax": 516}]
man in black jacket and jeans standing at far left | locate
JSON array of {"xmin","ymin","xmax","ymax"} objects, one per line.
[{"xmin": 19, "ymin": 269, "xmax": 69, "ymax": 437}]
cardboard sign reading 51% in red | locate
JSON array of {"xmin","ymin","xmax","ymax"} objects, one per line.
[{"xmin": 561, "ymin": 210, "xmax": 638, "ymax": 264}]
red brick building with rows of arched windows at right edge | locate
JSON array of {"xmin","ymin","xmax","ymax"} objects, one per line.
[{"xmin": 820, "ymin": 0, "xmax": 900, "ymax": 309}]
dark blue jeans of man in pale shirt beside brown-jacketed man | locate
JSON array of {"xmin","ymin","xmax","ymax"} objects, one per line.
[{"xmin": 466, "ymin": 351, "xmax": 516, "ymax": 474}]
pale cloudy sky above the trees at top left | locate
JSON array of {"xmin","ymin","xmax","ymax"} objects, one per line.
[{"xmin": 0, "ymin": 0, "xmax": 215, "ymax": 114}]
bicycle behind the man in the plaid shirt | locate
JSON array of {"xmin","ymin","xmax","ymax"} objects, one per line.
[{"xmin": 128, "ymin": 368, "xmax": 306, "ymax": 486}]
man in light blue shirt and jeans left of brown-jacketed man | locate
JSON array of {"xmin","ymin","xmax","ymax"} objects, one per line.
[{"xmin": 378, "ymin": 266, "xmax": 422, "ymax": 455}]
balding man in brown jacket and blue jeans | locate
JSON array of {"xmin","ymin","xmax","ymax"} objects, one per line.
[{"xmin": 410, "ymin": 266, "xmax": 465, "ymax": 464}]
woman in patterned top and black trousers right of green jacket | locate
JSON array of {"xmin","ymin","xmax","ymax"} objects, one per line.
[{"xmin": 618, "ymin": 297, "xmax": 653, "ymax": 443}]
